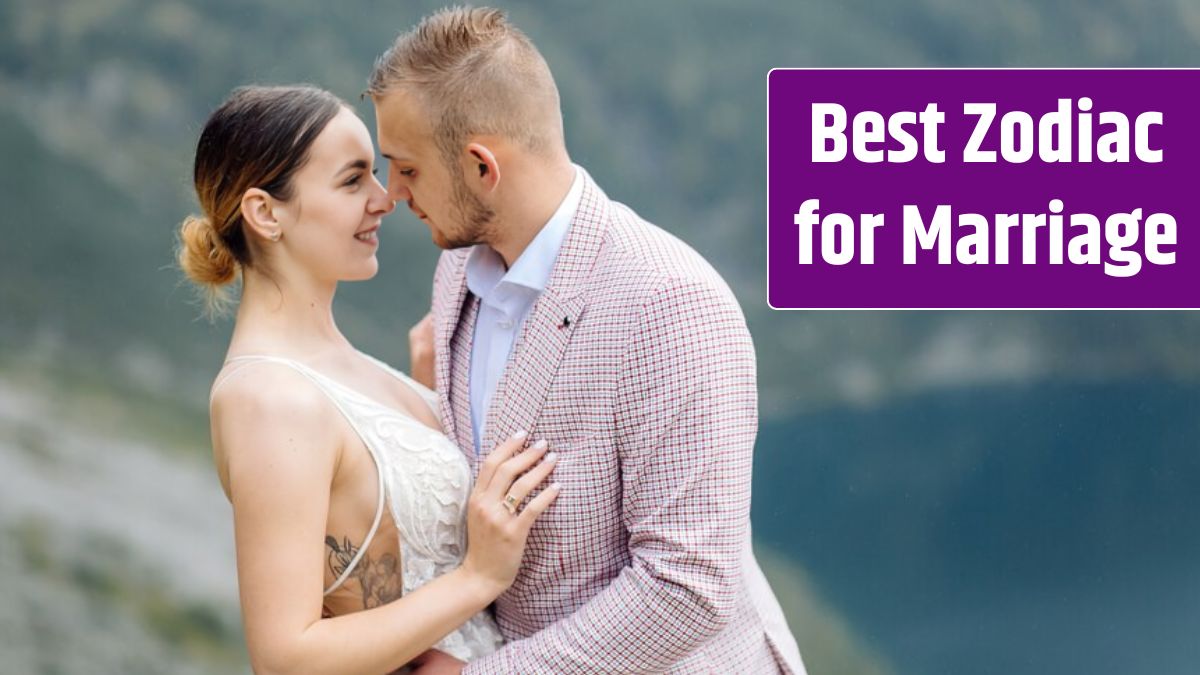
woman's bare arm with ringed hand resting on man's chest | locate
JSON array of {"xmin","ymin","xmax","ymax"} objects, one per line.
[{"xmin": 212, "ymin": 368, "xmax": 554, "ymax": 674}]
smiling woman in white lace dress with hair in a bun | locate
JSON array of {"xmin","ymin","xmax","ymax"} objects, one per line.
[{"xmin": 180, "ymin": 86, "xmax": 558, "ymax": 674}]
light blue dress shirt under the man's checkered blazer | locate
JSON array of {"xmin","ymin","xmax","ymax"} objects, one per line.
[{"xmin": 467, "ymin": 166, "xmax": 583, "ymax": 454}]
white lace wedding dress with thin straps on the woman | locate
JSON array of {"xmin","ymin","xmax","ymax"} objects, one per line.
[{"xmin": 212, "ymin": 354, "xmax": 504, "ymax": 661}]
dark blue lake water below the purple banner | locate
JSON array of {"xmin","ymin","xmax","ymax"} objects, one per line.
[{"xmin": 754, "ymin": 381, "xmax": 1200, "ymax": 675}]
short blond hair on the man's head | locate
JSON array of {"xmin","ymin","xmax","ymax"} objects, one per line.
[{"xmin": 367, "ymin": 7, "xmax": 563, "ymax": 162}]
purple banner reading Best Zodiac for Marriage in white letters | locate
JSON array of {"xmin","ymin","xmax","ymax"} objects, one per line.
[{"xmin": 767, "ymin": 70, "xmax": 1200, "ymax": 309}]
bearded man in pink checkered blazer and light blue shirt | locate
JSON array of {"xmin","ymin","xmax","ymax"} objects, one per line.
[{"xmin": 368, "ymin": 8, "xmax": 804, "ymax": 674}]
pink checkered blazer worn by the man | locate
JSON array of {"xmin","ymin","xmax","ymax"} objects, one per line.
[{"xmin": 433, "ymin": 173, "xmax": 804, "ymax": 674}]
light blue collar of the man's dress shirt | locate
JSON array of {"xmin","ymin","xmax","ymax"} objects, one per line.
[{"xmin": 467, "ymin": 166, "xmax": 583, "ymax": 300}]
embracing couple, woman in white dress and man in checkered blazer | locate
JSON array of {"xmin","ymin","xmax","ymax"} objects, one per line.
[{"xmin": 180, "ymin": 8, "xmax": 804, "ymax": 674}]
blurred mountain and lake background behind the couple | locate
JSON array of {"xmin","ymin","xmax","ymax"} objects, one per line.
[{"xmin": 0, "ymin": 0, "xmax": 1200, "ymax": 675}]
